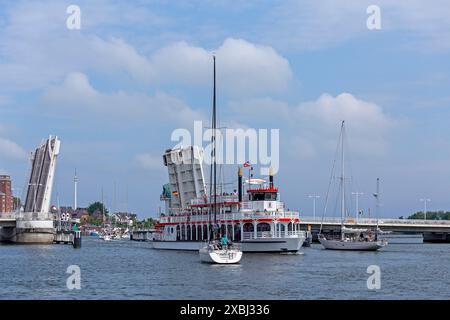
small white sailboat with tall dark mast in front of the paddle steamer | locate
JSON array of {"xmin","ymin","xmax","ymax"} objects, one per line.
[{"xmin": 199, "ymin": 56, "xmax": 242, "ymax": 264}]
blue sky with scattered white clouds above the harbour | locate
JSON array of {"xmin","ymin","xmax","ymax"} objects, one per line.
[{"xmin": 0, "ymin": 0, "xmax": 450, "ymax": 218}]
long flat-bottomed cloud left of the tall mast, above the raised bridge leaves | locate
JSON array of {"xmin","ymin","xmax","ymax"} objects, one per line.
[{"xmin": 41, "ymin": 72, "xmax": 203, "ymax": 125}]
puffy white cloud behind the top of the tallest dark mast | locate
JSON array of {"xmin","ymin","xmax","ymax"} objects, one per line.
[{"xmin": 121, "ymin": 38, "xmax": 293, "ymax": 96}]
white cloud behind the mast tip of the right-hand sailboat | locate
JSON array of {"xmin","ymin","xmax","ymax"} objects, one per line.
[{"xmin": 230, "ymin": 93, "xmax": 397, "ymax": 158}]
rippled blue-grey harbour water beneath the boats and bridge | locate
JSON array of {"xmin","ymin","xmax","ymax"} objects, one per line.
[{"xmin": 0, "ymin": 238, "xmax": 450, "ymax": 300}]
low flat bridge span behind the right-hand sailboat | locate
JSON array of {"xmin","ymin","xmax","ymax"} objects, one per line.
[{"xmin": 300, "ymin": 217, "xmax": 450, "ymax": 243}]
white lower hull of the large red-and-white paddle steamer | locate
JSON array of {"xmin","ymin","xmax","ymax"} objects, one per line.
[{"xmin": 150, "ymin": 236, "xmax": 305, "ymax": 253}]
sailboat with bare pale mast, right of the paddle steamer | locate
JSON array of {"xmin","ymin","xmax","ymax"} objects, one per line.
[{"xmin": 319, "ymin": 121, "xmax": 387, "ymax": 251}]
